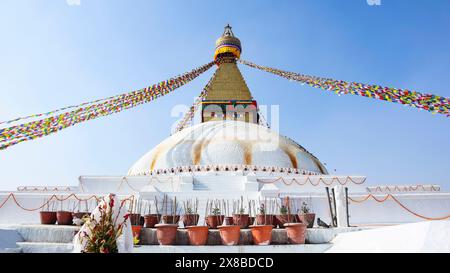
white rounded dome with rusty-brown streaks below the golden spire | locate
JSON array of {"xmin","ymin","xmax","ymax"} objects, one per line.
[{"xmin": 128, "ymin": 121, "xmax": 327, "ymax": 175}]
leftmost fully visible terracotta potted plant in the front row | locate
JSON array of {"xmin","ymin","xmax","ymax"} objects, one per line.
[{"xmin": 155, "ymin": 195, "xmax": 180, "ymax": 245}]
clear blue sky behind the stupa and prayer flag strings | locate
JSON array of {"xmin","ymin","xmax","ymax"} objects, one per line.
[{"xmin": 0, "ymin": 0, "xmax": 450, "ymax": 190}]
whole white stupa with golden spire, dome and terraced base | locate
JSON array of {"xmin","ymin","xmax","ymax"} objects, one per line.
[{"xmin": 0, "ymin": 25, "xmax": 450, "ymax": 251}]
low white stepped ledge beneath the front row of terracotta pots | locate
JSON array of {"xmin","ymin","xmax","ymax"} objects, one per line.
[{"xmin": 0, "ymin": 224, "xmax": 365, "ymax": 253}]
